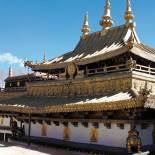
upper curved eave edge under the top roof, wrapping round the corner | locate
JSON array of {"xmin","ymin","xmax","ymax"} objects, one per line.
[{"xmin": 24, "ymin": 44, "xmax": 155, "ymax": 71}]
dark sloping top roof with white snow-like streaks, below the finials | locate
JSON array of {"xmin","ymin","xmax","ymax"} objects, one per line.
[{"xmin": 25, "ymin": 24, "xmax": 146, "ymax": 71}]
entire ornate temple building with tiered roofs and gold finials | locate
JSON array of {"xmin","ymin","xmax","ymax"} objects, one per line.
[{"xmin": 0, "ymin": 0, "xmax": 155, "ymax": 154}]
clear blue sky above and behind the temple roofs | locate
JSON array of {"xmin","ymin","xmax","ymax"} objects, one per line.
[{"xmin": 0, "ymin": 0, "xmax": 155, "ymax": 86}]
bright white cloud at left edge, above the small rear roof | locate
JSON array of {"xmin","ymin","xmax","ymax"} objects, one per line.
[{"xmin": 0, "ymin": 53, "xmax": 23, "ymax": 66}]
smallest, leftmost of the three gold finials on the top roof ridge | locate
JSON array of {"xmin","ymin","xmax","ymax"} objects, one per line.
[{"xmin": 81, "ymin": 12, "xmax": 90, "ymax": 37}]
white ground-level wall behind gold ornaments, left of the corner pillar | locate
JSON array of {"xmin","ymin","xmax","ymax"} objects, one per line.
[{"xmin": 25, "ymin": 123, "xmax": 130, "ymax": 147}]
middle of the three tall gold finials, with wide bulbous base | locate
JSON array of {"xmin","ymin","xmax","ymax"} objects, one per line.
[{"xmin": 100, "ymin": 0, "xmax": 113, "ymax": 29}]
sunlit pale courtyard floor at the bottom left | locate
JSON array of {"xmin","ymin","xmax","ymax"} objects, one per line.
[{"xmin": 0, "ymin": 141, "xmax": 86, "ymax": 155}]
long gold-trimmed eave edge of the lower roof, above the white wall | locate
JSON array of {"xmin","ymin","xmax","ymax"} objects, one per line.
[{"xmin": 0, "ymin": 97, "xmax": 144, "ymax": 114}]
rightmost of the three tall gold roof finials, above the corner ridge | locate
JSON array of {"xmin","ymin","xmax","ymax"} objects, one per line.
[{"xmin": 124, "ymin": 0, "xmax": 134, "ymax": 24}]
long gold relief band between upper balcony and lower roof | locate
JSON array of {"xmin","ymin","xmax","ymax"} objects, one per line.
[{"xmin": 27, "ymin": 73, "xmax": 132, "ymax": 97}]
